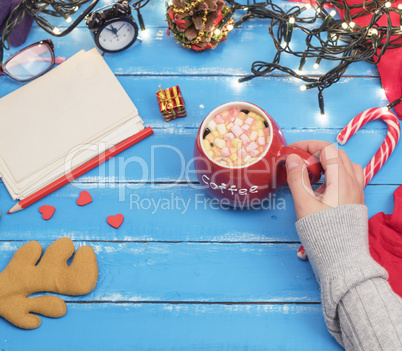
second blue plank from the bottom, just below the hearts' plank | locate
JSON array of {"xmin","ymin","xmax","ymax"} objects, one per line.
[{"xmin": 0, "ymin": 242, "xmax": 321, "ymax": 302}]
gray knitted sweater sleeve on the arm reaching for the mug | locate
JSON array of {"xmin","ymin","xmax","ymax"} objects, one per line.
[{"xmin": 296, "ymin": 205, "xmax": 402, "ymax": 351}]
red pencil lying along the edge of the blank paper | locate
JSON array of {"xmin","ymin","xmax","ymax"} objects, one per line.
[{"xmin": 7, "ymin": 127, "xmax": 154, "ymax": 213}]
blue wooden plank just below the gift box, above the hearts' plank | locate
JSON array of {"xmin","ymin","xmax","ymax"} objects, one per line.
[{"xmin": 0, "ymin": 128, "xmax": 396, "ymax": 187}]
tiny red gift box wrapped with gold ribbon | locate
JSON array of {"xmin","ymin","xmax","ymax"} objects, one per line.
[{"xmin": 156, "ymin": 85, "xmax": 187, "ymax": 122}]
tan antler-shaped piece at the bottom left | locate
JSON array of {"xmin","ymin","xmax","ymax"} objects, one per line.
[{"xmin": 0, "ymin": 238, "xmax": 98, "ymax": 329}]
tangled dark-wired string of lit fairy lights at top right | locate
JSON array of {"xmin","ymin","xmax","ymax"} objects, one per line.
[{"xmin": 227, "ymin": 0, "xmax": 402, "ymax": 115}]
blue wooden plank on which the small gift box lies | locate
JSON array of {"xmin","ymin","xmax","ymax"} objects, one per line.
[{"xmin": 0, "ymin": 76, "xmax": 388, "ymax": 129}]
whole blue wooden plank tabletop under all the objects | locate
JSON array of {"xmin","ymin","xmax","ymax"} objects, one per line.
[{"xmin": 0, "ymin": 0, "xmax": 402, "ymax": 351}]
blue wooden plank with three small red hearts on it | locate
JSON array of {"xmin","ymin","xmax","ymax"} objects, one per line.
[{"xmin": 0, "ymin": 183, "xmax": 397, "ymax": 242}]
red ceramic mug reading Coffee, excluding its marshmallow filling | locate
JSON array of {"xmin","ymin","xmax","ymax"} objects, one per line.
[{"xmin": 194, "ymin": 101, "xmax": 322, "ymax": 207}]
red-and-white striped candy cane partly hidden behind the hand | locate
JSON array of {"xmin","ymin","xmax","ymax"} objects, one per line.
[{"xmin": 297, "ymin": 107, "xmax": 401, "ymax": 260}]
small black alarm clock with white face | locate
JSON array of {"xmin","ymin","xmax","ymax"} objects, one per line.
[{"xmin": 85, "ymin": 1, "xmax": 138, "ymax": 53}]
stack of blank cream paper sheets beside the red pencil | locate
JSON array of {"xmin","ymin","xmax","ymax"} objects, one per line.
[{"xmin": 0, "ymin": 49, "xmax": 144, "ymax": 200}]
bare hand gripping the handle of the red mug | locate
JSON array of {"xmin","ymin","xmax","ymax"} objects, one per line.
[{"xmin": 286, "ymin": 140, "xmax": 364, "ymax": 219}]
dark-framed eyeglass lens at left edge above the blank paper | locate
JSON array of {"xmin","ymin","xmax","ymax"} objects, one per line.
[{"xmin": 0, "ymin": 39, "xmax": 66, "ymax": 82}]
